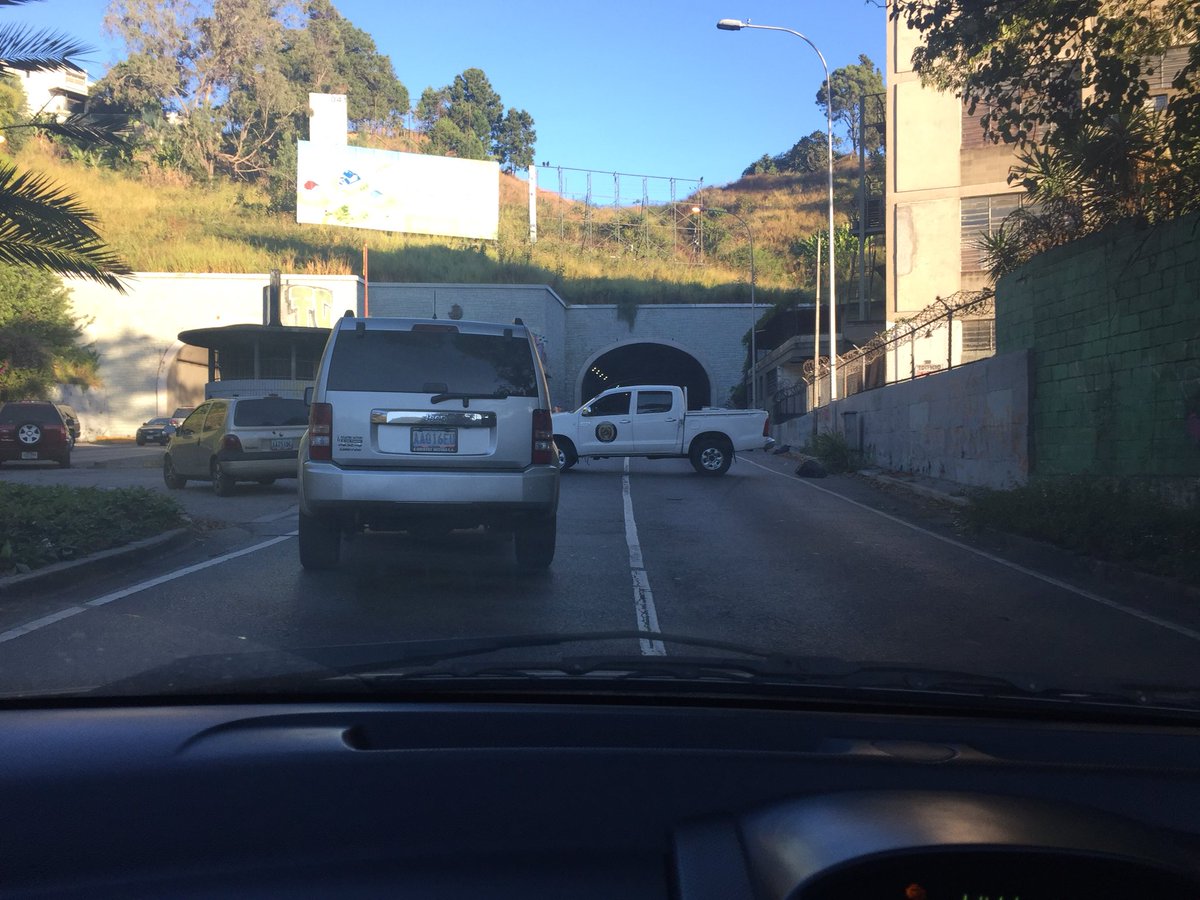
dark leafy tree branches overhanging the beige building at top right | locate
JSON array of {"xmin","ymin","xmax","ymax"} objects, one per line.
[{"xmin": 889, "ymin": 0, "xmax": 1200, "ymax": 222}]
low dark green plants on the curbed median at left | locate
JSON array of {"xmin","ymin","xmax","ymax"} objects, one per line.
[{"xmin": 0, "ymin": 481, "xmax": 186, "ymax": 576}]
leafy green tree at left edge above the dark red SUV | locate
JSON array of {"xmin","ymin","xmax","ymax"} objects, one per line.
[{"xmin": 0, "ymin": 264, "xmax": 100, "ymax": 400}]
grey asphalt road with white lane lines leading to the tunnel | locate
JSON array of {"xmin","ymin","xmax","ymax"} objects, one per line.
[{"xmin": 0, "ymin": 448, "xmax": 1200, "ymax": 695}]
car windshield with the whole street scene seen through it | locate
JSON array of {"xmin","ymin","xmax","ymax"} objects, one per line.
[{"xmin": 0, "ymin": 0, "xmax": 1200, "ymax": 712}]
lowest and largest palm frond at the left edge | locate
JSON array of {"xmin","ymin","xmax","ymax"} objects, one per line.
[{"xmin": 0, "ymin": 163, "xmax": 132, "ymax": 293}]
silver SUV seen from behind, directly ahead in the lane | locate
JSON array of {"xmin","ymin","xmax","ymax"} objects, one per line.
[{"xmin": 299, "ymin": 313, "xmax": 558, "ymax": 569}]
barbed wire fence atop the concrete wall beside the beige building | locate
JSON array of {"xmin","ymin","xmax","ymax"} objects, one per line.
[{"xmin": 772, "ymin": 288, "xmax": 996, "ymax": 422}]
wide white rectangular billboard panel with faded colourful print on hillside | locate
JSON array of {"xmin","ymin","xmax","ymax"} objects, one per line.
[{"xmin": 296, "ymin": 140, "xmax": 500, "ymax": 240}]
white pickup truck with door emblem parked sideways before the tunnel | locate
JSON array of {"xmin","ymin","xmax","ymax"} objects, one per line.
[{"xmin": 553, "ymin": 384, "xmax": 775, "ymax": 475}]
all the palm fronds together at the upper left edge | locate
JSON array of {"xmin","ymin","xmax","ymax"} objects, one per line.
[{"xmin": 0, "ymin": 0, "xmax": 130, "ymax": 292}]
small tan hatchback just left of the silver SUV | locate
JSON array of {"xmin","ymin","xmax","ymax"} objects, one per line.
[{"xmin": 162, "ymin": 396, "xmax": 308, "ymax": 497}]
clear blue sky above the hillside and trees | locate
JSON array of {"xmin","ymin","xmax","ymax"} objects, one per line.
[{"xmin": 9, "ymin": 0, "xmax": 886, "ymax": 185}]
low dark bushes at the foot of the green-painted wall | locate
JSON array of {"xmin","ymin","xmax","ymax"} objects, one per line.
[{"xmin": 964, "ymin": 478, "xmax": 1200, "ymax": 586}]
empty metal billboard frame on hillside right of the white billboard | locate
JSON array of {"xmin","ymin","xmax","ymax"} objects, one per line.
[{"xmin": 536, "ymin": 163, "xmax": 704, "ymax": 263}]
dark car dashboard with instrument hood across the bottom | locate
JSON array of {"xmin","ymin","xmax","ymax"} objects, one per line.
[{"xmin": 0, "ymin": 697, "xmax": 1200, "ymax": 900}]
